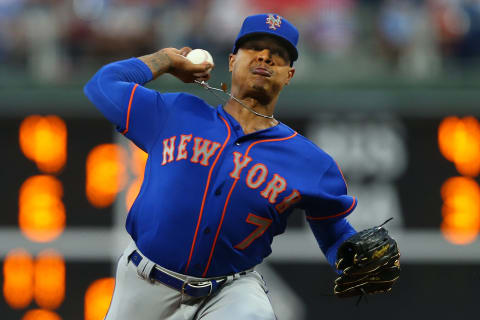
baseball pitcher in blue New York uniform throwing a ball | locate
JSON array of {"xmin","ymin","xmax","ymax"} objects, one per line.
[{"xmin": 84, "ymin": 14, "xmax": 399, "ymax": 320}]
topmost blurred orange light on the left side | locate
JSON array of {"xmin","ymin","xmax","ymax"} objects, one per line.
[{"xmin": 19, "ymin": 115, "xmax": 67, "ymax": 173}]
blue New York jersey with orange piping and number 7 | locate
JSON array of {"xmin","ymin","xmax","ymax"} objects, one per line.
[{"xmin": 85, "ymin": 58, "xmax": 357, "ymax": 277}]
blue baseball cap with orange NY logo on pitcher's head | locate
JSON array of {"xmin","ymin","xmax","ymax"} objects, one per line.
[{"xmin": 233, "ymin": 13, "xmax": 298, "ymax": 65}]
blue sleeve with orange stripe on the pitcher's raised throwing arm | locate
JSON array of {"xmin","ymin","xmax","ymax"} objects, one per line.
[{"xmin": 84, "ymin": 58, "xmax": 178, "ymax": 152}]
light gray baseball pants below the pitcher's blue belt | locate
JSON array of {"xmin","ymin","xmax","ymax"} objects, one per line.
[{"xmin": 105, "ymin": 241, "xmax": 276, "ymax": 320}]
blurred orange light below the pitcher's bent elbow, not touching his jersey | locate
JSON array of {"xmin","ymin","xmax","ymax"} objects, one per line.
[{"xmin": 86, "ymin": 144, "xmax": 127, "ymax": 208}]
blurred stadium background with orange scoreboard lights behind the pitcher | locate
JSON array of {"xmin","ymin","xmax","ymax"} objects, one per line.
[{"xmin": 0, "ymin": 0, "xmax": 480, "ymax": 320}]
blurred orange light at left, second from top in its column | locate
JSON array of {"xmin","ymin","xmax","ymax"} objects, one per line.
[{"xmin": 18, "ymin": 175, "xmax": 66, "ymax": 242}]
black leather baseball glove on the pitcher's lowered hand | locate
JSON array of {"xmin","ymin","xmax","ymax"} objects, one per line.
[{"xmin": 333, "ymin": 223, "xmax": 400, "ymax": 298}]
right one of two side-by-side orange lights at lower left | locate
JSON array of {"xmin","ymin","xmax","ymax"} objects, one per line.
[{"xmin": 34, "ymin": 250, "xmax": 65, "ymax": 310}]
